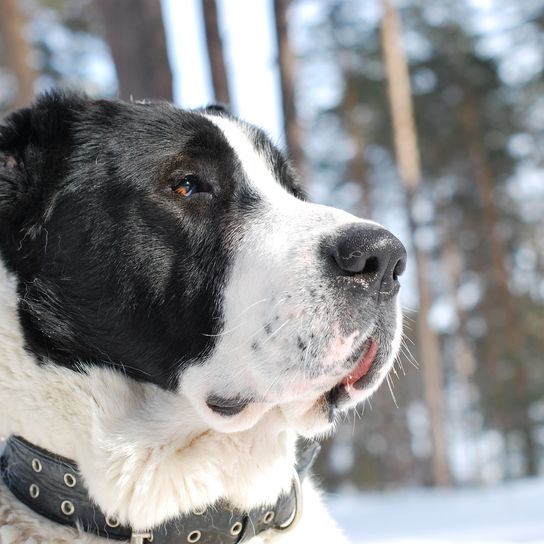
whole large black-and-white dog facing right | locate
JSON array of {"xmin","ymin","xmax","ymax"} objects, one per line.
[{"xmin": 0, "ymin": 92, "xmax": 406, "ymax": 544}]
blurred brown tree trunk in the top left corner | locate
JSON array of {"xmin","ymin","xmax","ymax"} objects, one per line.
[{"xmin": 0, "ymin": 0, "xmax": 36, "ymax": 108}]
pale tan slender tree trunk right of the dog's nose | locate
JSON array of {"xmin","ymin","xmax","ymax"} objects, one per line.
[{"xmin": 381, "ymin": 0, "xmax": 451, "ymax": 485}]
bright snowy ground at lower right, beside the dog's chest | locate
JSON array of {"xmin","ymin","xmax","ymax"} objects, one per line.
[{"xmin": 329, "ymin": 479, "xmax": 544, "ymax": 544}]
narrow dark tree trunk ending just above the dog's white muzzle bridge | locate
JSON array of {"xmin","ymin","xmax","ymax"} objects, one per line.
[{"xmin": 274, "ymin": 0, "xmax": 305, "ymax": 178}]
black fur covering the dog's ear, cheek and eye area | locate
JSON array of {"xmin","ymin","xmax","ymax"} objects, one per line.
[{"xmin": 0, "ymin": 93, "xmax": 298, "ymax": 388}]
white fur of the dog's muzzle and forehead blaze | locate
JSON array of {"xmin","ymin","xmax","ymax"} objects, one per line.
[{"xmin": 189, "ymin": 115, "xmax": 401, "ymax": 436}]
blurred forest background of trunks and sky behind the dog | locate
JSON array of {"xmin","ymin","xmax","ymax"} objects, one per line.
[{"xmin": 0, "ymin": 0, "xmax": 544, "ymax": 492}]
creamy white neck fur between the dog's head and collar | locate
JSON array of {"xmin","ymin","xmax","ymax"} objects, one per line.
[{"xmin": 0, "ymin": 262, "xmax": 295, "ymax": 529}]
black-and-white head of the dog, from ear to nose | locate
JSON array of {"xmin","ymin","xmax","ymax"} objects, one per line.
[{"xmin": 0, "ymin": 93, "xmax": 406, "ymax": 435}]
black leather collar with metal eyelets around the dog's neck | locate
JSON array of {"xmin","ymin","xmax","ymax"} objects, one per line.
[{"xmin": 0, "ymin": 436, "xmax": 320, "ymax": 544}]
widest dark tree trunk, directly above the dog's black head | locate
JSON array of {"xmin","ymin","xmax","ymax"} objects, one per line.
[{"xmin": 95, "ymin": 0, "xmax": 172, "ymax": 100}]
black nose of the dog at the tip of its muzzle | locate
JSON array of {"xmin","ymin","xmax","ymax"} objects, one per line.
[{"xmin": 329, "ymin": 224, "xmax": 406, "ymax": 299}]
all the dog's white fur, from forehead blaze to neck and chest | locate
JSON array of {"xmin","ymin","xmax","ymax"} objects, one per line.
[{"xmin": 0, "ymin": 117, "xmax": 400, "ymax": 544}]
